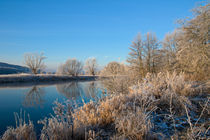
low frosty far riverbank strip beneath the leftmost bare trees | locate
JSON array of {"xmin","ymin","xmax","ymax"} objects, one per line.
[{"xmin": 0, "ymin": 74, "xmax": 99, "ymax": 85}]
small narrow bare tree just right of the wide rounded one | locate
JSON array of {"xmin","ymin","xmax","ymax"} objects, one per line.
[{"xmin": 85, "ymin": 58, "xmax": 98, "ymax": 76}]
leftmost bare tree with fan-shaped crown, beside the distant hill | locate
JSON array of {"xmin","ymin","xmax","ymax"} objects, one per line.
[{"xmin": 24, "ymin": 53, "xmax": 46, "ymax": 74}]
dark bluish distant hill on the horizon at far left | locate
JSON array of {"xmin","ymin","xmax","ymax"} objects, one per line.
[{"xmin": 0, "ymin": 62, "xmax": 30, "ymax": 75}]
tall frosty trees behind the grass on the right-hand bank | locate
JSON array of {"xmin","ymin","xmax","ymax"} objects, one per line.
[{"xmin": 127, "ymin": 4, "xmax": 210, "ymax": 80}]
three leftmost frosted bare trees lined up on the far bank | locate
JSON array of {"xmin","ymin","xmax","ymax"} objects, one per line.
[{"xmin": 24, "ymin": 53, "xmax": 98, "ymax": 76}]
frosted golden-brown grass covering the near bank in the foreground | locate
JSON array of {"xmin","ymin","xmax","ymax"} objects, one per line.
[{"xmin": 2, "ymin": 73, "xmax": 210, "ymax": 140}]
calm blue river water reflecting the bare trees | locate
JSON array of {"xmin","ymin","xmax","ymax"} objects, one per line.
[{"xmin": 0, "ymin": 81, "xmax": 104, "ymax": 135}]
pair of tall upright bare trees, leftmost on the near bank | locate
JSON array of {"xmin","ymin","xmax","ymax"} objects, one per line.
[{"xmin": 127, "ymin": 33, "xmax": 159, "ymax": 77}]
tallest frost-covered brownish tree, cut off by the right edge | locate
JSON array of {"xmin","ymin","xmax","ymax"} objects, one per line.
[{"xmin": 176, "ymin": 4, "xmax": 210, "ymax": 79}]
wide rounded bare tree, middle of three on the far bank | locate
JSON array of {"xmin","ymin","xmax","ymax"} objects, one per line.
[{"xmin": 62, "ymin": 59, "xmax": 83, "ymax": 76}]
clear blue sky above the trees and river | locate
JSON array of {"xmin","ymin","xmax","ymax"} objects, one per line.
[{"xmin": 0, "ymin": 0, "xmax": 203, "ymax": 68}]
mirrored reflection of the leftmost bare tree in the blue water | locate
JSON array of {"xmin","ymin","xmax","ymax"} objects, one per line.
[{"xmin": 23, "ymin": 86, "xmax": 45, "ymax": 107}]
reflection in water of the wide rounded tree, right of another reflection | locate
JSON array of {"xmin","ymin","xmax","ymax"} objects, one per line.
[{"xmin": 56, "ymin": 82, "xmax": 82, "ymax": 99}]
